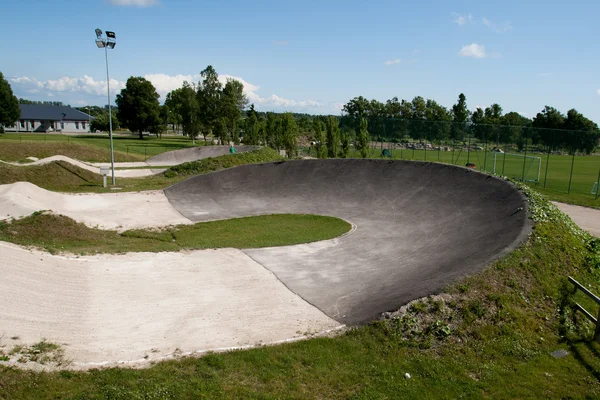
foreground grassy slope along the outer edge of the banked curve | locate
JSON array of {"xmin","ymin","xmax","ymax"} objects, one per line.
[{"xmin": 0, "ymin": 185, "xmax": 600, "ymax": 399}]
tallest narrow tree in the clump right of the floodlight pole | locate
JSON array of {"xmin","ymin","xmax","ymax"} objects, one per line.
[{"xmin": 197, "ymin": 65, "xmax": 227, "ymax": 144}]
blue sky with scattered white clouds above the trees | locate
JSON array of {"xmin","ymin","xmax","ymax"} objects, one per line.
[{"xmin": 0, "ymin": 0, "xmax": 600, "ymax": 123}]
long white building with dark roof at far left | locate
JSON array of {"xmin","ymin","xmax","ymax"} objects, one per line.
[{"xmin": 4, "ymin": 104, "xmax": 94, "ymax": 133}]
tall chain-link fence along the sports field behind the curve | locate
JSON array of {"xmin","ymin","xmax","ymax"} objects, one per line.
[{"xmin": 307, "ymin": 117, "xmax": 600, "ymax": 199}]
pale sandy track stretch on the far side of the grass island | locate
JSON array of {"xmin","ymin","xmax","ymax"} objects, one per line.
[{"xmin": 0, "ymin": 182, "xmax": 191, "ymax": 230}]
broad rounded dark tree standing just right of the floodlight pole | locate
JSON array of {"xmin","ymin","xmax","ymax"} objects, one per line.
[{"xmin": 116, "ymin": 76, "xmax": 160, "ymax": 139}]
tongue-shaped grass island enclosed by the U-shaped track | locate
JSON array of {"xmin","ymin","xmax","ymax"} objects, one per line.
[{"xmin": 0, "ymin": 212, "xmax": 351, "ymax": 254}]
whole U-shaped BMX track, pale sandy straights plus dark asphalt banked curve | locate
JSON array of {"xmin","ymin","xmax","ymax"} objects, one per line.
[{"xmin": 0, "ymin": 160, "xmax": 530, "ymax": 368}]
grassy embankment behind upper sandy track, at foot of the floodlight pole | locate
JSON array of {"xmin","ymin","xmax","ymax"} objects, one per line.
[{"xmin": 0, "ymin": 148, "xmax": 283, "ymax": 192}]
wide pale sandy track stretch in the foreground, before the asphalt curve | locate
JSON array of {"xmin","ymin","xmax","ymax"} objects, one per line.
[{"xmin": 0, "ymin": 242, "xmax": 340, "ymax": 368}]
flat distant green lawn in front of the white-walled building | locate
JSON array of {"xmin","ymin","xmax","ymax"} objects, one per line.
[{"xmin": 0, "ymin": 133, "xmax": 204, "ymax": 161}]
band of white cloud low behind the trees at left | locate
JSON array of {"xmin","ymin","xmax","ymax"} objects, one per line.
[{"xmin": 9, "ymin": 74, "xmax": 330, "ymax": 113}]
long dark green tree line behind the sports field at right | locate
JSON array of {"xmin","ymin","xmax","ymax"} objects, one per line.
[{"xmin": 340, "ymin": 93, "xmax": 600, "ymax": 154}]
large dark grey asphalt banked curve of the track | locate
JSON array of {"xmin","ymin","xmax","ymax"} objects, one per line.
[{"xmin": 165, "ymin": 159, "xmax": 531, "ymax": 325}]
